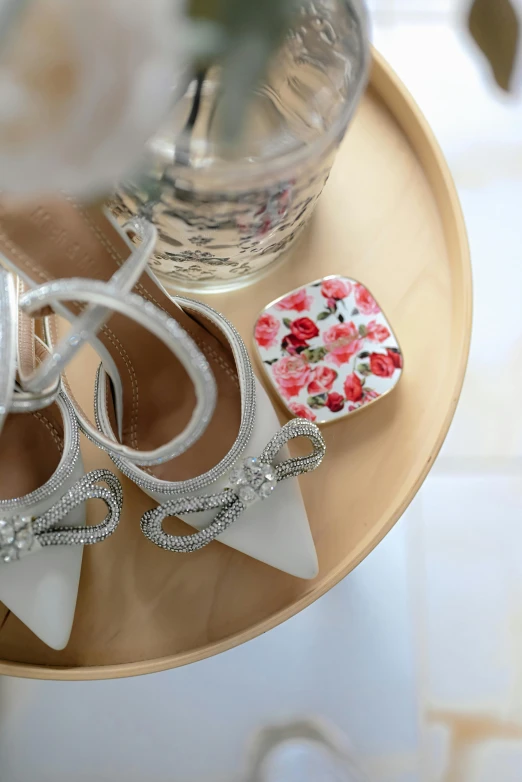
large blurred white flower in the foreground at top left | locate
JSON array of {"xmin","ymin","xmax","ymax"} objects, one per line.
[{"xmin": 0, "ymin": 0, "xmax": 184, "ymax": 195}]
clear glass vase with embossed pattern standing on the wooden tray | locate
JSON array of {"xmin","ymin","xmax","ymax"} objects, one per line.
[{"xmin": 111, "ymin": 0, "xmax": 369, "ymax": 292}]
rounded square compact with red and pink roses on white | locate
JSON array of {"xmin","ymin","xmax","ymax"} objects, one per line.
[{"xmin": 254, "ymin": 276, "xmax": 403, "ymax": 423}]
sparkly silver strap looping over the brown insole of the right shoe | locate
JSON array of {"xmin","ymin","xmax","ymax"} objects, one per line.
[{"xmin": 16, "ymin": 218, "xmax": 217, "ymax": 466}]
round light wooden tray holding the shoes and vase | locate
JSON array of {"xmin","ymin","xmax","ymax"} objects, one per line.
[{"xmin": 0, "ymin": 54, "xmax": 471, "ymax": 679}]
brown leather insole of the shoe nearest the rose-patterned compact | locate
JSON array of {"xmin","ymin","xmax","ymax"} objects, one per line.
[{"xmin": 0, "ymin": 197, "xmax": 241, "ymax": 481}]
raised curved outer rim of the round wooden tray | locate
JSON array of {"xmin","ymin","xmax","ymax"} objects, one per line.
[{"xmin": 0, "ymin": 47, "xmax": 472, "ymax": 681}]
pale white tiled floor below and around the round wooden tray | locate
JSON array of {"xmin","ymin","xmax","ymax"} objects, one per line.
[{"xmin": 0, "ymin": 11, "xmax": 522, "ymax": 782}]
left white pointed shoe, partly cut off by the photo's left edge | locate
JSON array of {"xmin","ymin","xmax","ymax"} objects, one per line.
[{"xmin": 0, "ymin": 270, "xmax": 122, "ymax": 649}]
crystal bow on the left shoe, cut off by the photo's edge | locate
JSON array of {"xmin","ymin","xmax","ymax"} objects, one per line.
[{"xmin": 0, "ymin": 470, "xmax": 123, "ymax": 562}]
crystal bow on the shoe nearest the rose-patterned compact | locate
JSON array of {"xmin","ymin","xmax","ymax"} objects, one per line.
[{"xmin": 141, "ymin": 418, "xmax": 326, "ymax": 553}]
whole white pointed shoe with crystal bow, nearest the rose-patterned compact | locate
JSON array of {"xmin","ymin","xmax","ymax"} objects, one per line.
[{"xmin": 0, "ymin": 198, "xmax": 325, "ymax": 652}]
